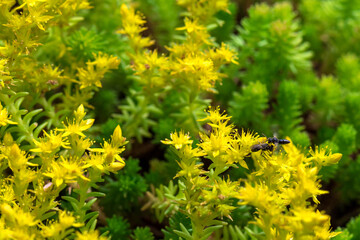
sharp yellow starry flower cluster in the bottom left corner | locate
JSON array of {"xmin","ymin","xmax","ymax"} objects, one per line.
[{"xmin": 0, "ymin": 105, "xmax": 127, "ymax": 239}]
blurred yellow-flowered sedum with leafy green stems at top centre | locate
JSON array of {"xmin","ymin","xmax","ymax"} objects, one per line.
[{"xmin": 115, "ymin": 1, "xmax": 236, "ymax": 141}]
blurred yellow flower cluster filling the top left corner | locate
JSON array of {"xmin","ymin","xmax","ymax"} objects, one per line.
[{"xmin": 0, "ymin": 0, "xmax": 119, "ymax": 111}]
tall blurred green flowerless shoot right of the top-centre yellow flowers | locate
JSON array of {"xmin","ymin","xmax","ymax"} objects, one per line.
[{"xmin": 233, "ymin": 2, "xmax": 312, "ymax": 90}]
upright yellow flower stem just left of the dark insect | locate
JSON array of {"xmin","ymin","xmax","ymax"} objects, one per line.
[{"xmin": 162, "ymin": 108, "xmax": 258, "ymax": 239}]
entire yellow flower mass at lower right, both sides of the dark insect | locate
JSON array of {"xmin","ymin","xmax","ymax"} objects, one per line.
[{"xmin": 162, "ymin": 108, "xmax": 342, "ymax": 240}]
